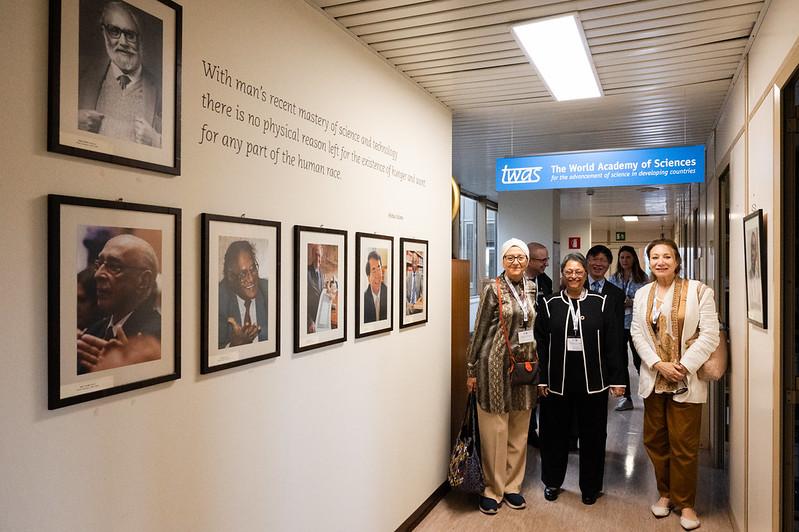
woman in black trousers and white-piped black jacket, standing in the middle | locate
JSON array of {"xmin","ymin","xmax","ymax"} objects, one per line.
[{"xmin": 535, "ymin": 253, "xmax": 626, "ymax": 504}]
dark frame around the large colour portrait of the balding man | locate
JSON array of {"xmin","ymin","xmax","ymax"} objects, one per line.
[{"xmin": 47, "ymin": 194, "xmax": 181, "ymax": 410}]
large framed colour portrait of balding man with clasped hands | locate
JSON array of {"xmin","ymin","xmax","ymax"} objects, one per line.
[{"xmin": 47, "ymin": 195, "xmax": 180, "ymax": 410}]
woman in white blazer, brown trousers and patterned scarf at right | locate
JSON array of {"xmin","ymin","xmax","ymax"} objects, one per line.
[{"xmin": 630, "ymin": 239, "xmax": 719, "ymax": 530}]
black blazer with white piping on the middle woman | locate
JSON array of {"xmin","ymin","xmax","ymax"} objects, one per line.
[{"xmin": 535, "ymin": 291, "xmax": 627, "ymax": 395}]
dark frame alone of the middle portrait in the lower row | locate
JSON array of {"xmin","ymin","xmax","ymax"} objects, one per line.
[{"xmin": 294, "ymin": 225, "xmax": 349, "ymax": 353}]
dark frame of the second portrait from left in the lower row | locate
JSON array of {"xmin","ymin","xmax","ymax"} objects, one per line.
[{"xmin": 200, "ymin": 213, "xmax": 281, "ymax": 374}]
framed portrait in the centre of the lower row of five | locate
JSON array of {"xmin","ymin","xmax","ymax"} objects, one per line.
[{"xmin": 294, "ymin": 225, "xmax": 347, "ymax": 353}]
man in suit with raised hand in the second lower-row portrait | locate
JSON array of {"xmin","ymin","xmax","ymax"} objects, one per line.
[{"xmin": 219, "ymin": 240, "xmax": 268, "ymax": 349}]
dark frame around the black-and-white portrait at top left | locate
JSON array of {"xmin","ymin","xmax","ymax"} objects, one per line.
[{"xmin": 47, "ymin": 0, "xmax": 183, "ymax": 175}]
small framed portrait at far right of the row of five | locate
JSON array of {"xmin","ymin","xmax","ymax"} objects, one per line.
[{"xmin": 399, "ymin": 238, "xmax": 427, "ymax": 328}]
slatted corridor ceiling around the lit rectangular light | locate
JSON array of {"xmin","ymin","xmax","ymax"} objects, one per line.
[{"xmin": 306, "ymin": 0, "xmax": 766, "ymax": 214}]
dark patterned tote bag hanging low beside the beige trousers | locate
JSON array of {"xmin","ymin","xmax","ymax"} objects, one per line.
[{"xmin": 447, "ymin": 392, "xmax": 485, "ymax": 494}]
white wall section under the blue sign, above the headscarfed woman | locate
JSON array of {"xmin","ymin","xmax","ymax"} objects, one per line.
[{"xmin": 497, "ymin": 190, "xmax": 563, "ymax": 277}]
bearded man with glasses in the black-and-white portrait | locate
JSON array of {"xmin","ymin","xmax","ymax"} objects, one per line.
[{"xmin": 78, "ymin": 1, "xmax": 161, "ymax": 148}]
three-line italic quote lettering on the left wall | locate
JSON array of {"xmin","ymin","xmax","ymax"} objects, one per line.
[{"xmin": 196, "ymin": 60, "xmax": 427, "ymax": 187}]
